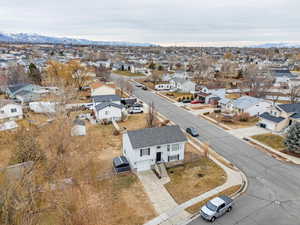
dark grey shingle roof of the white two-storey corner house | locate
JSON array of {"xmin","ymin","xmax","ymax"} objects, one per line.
[{"xmin": 127, "ymin": 126, "xmax": 187, "ymax": 149}]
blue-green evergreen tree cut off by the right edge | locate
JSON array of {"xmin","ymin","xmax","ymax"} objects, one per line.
[{"xmin": 284, "ymin": 123, "xmax": 300, "ymax": 154}]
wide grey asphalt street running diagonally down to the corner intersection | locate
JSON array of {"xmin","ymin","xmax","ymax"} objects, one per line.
[{"xmin": 135, "ymin": 88, "xmax": 300, "ymax": 225}]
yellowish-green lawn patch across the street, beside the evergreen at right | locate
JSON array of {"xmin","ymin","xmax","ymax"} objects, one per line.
[{"xmin": 252, "ymin": 134, "xmax": 285, "ymax": 151}]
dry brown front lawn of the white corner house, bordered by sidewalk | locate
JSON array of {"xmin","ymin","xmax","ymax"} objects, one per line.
[{"xmin": 165, "ymin": 144, "xmax": 226, "ymax": 204}]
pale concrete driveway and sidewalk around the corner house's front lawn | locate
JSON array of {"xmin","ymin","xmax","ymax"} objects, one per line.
[{"xmin": 142, "ymin": 142, "xmax": 246, "ymax": 225}]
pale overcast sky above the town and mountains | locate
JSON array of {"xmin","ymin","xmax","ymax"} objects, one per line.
[{"xmin": 0, "ymin": 0, "xmax": 300, "ymax": 45}]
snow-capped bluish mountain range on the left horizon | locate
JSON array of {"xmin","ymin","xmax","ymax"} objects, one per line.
[{"xmin": 0, "ymin": 32, "xmax": 155, "ymax": 47}]
